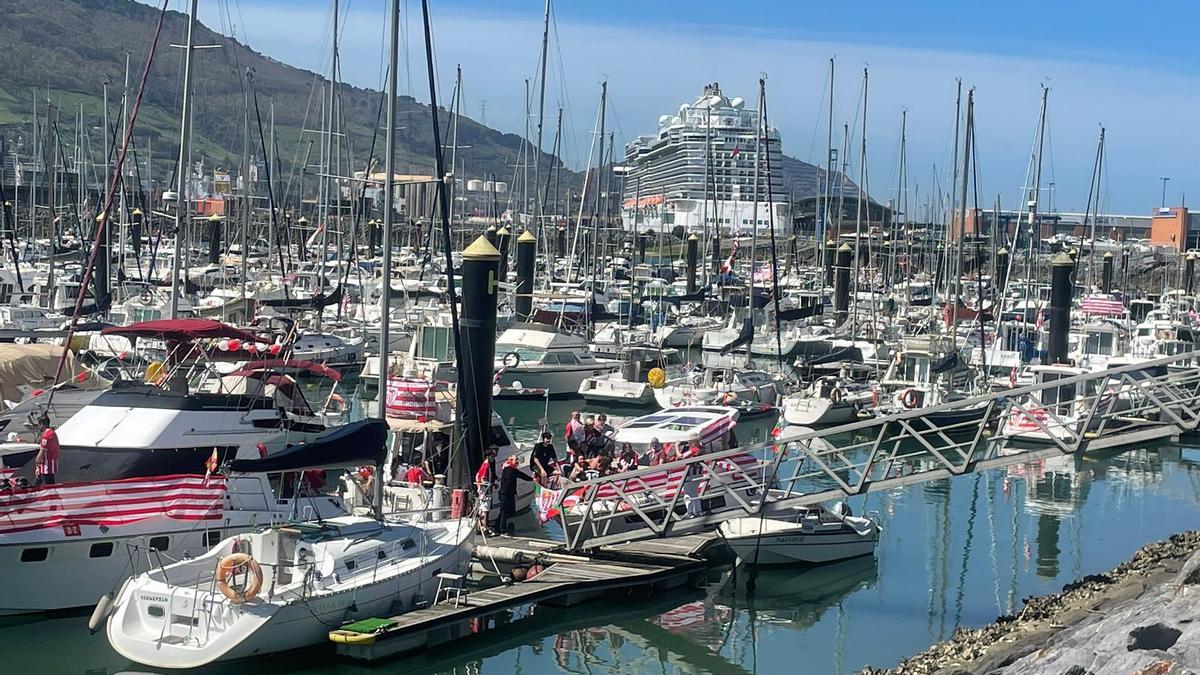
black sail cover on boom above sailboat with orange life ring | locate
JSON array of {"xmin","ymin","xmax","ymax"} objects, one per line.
[{"xmin": 229, "ymin": 419, "xmax": 388, "ymax": 473}]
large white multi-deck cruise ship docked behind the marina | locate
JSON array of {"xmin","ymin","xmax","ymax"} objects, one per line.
[{"xmin": 622, "ymin": 83, "xmax": 791, "ymax": 234}]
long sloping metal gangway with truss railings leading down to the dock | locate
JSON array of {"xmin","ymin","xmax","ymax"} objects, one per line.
[{"xmin": 556, "ymin": 351, "xmax": 1200, "ymax": 550}]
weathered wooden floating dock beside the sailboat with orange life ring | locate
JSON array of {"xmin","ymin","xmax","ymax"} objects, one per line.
[{"xmin": 330, "ymin": 532, "xmax": 721, "ymax": 662}]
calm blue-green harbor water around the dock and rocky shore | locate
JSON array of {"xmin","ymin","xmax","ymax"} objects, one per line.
[{"xmin": 14, "ymin": 384, "xmax": 1200, "ymax": 675}]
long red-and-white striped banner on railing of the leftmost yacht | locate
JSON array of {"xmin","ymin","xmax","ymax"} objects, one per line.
[{"xmin": 0, "ymin": 474, "xmax": 226, "ymax": 534}]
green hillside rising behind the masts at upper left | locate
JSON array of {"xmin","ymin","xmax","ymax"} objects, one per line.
[{"xmin": 0, "ymin": 0, "xmax": 552, "ymax": 192}]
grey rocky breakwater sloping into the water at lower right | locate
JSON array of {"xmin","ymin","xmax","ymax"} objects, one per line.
[{"xmin": 863, "ymin": 531, "xmax": 1200, "ymax": 675}]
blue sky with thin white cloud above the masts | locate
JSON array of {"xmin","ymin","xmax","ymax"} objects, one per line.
[{"xmin": 172, "ymin": 0, "xmax": 1200, "ymax": 213}]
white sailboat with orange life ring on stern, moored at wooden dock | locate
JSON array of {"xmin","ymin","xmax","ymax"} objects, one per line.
[{"xmin": 106, "ymin": 419, "xmax": 474, "ymax": 668}]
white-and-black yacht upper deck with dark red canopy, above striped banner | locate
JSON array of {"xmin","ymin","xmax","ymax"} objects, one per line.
[{"xmin": 46, "ymin": 319, "xmax": 344, "ymax": 480}]
